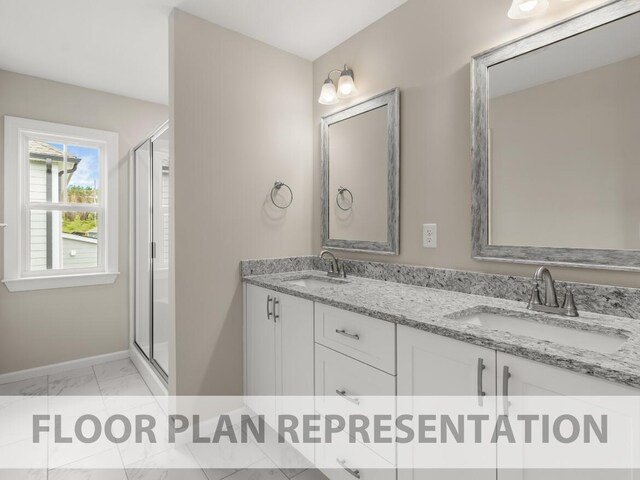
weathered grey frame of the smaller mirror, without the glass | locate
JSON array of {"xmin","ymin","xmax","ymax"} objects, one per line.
[{"xmin": 320, "ymin": 88, "xmax": 400, "ymax": 255}]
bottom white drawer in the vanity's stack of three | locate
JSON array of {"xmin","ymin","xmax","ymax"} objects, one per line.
[{"xmin": 316, "ymin": 426, "xmax": 396, "ymax": 480}]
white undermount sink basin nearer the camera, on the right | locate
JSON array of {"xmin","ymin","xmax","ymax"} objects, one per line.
[{"xmin": 458, "ymin": 312, "xmax": 627, "ymax": 353}]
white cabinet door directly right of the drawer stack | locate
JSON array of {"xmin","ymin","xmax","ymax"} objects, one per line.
[{"xmin": 398, "ymin": 326, "xmax": 496, "ymax": 480}]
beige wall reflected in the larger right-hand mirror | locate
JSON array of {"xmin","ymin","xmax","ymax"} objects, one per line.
[{"xmin": 489, "ymin": 57, "xmax": 640, "ymax": 250}]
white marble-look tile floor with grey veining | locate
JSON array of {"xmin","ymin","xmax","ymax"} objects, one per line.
[{"xmin": 0, "ymin": 359, "xmax": 326, "ymax": 480}]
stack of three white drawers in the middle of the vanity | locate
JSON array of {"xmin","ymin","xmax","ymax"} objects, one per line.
[{"xmin": 315, "ymin": 303, "xmax": 396, "ymax": 480}]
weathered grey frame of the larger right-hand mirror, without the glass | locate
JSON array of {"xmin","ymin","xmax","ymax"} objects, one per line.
[{"xmin": 471, "ymin": 0, "xmax": 640, "ymax": 271}]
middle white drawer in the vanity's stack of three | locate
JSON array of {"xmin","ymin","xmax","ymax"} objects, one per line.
[{"xmin": 316, "ymin": 344, "xmax": 396, "ymax": 465}]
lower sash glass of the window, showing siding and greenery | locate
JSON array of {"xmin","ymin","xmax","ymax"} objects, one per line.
[{"xmin": 29, "ymin": 210, "xmax": 99, "ymax": 271}]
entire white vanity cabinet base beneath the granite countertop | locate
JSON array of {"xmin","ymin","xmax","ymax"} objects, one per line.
[{"xmin": 244, "ymin": 284, "xmax": 640, "ymax": 480}]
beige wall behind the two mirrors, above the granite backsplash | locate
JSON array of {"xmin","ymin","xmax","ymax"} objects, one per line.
[{"xmin": 313, "ymin": 0, "xmax": 640, "ymax": 287}]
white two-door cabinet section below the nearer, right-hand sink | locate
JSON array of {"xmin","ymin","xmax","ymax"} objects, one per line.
[{"xmin": 398, "ymin": 326, "xmax": 640, "ymax": 480}]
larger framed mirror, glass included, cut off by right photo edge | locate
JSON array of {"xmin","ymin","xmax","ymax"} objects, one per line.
[{"xmin": 471, "ymin": 0, "xmax": 640, "ymax": 270}]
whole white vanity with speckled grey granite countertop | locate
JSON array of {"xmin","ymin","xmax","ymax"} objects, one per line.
[{"xmin": 244, "ymin": 264, "xmax": 640, "ymax": 480}]
